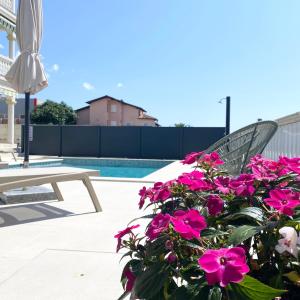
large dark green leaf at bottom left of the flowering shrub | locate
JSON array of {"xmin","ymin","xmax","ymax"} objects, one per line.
[{"xmin": 133, "ymin": 262, "xmax": 168, "ymax": 299}]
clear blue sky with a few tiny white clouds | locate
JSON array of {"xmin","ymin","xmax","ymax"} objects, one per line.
[{"xmin": 4, "ymin": 0, "xmax": 300, "ymax": 130}]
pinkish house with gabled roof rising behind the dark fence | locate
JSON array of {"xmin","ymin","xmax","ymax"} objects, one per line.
[{"xmin": 76, "ymin": 95, "xmax": 158, "ymax": 127}]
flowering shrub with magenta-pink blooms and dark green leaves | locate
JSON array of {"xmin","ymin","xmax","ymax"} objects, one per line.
[{"xmin": 115, "ymin": 152, "xmax": 300, "ymax": 300}]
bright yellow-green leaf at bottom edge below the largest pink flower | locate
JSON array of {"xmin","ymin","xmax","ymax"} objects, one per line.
[{"xmin": 227, "ymin": 275, "xmax": 287, "ymax": 300}]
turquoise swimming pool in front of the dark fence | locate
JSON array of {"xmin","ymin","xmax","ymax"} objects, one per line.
[{"xmin": 10, "ymin": 158, "xmax": 173, "ymax": 178}]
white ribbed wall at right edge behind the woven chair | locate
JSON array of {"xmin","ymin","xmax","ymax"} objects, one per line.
[{"xmin": 263, "ymin": 121, "xmax": 300, "ymax": 160}]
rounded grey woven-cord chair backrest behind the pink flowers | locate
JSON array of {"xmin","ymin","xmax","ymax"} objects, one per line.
[{"xmin": 205, "ymin": 121, "xmax": 278, "ymax": 175}]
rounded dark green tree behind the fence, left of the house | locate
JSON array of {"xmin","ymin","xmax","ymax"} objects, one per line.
[{"xmin": 31, "ymin": 100, "xmax": 76, "ymax": 125}]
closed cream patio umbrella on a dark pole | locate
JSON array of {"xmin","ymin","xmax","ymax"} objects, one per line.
[{"xmin": 5, "ymin": 0, "xmax": 48, "ymax": 167}]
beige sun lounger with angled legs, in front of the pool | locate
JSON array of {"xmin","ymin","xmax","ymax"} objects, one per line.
[{"xmin": 0, "ymin": 167, "xmax": 102, "ymax": 212}]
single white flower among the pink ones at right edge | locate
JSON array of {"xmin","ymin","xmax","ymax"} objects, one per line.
[{"xmin": 275, "ymin": 227, "xmax": 298, "ymax": 258}]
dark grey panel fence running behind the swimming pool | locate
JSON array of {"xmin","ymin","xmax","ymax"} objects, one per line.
[{"xmin": 24, "ymin": 125, "xmax": 225, "ymax": 159}]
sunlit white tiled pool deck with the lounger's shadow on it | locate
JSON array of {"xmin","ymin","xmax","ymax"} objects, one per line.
[{"xmin": 0, "ymin": 158, "xmax": 191, "ymax": 300}]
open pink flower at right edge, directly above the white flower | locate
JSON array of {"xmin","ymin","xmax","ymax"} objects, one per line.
[{"xmin": 264, "ymin": 189, "xmax": 300, "ymax": 216}]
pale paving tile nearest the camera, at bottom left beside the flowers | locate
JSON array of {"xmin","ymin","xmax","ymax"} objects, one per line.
[{"xmin": 0, "ymin": 249, "xmax": 122, "ymax": 300}]
